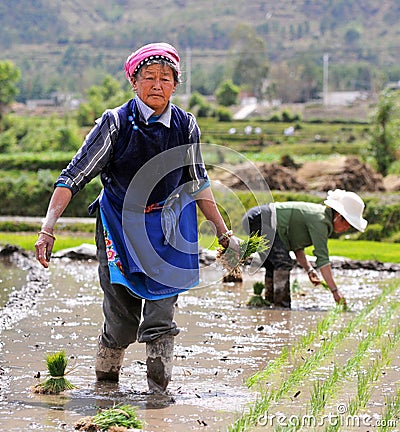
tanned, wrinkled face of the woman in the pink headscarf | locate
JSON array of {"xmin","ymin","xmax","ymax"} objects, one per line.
[{"xmin": 132, "ymin": 63, "xmax": 176, "ymax": 115}]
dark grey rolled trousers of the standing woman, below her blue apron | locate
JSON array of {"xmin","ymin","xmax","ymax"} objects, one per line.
[{"xmin": 96, "ymin": 215, "xmax": 179, "ymax": 348}]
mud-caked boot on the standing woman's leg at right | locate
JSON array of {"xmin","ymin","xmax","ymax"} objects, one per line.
[{"xmin": 146, "ymin": 334, "xmax": 174, "ymax": 393}]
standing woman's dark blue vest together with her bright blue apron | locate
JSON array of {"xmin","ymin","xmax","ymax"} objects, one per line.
[{"xmin": 95, "ymin": 100, "xmax": 199, "ymax": 299}]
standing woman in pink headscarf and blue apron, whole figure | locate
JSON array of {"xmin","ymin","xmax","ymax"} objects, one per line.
[{"xmin": 35, "ymin": 43, "xmax": 239, "ymax": 392}]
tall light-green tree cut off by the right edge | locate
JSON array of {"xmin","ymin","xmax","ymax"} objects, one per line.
[{"xmin": 369, "ymin": 90, "xmax": 400, "ymax": 175}]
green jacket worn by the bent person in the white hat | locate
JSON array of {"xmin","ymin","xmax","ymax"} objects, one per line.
[{"xmin": 274, "ymin": 201, "xmax": 333, "ymax": 268}]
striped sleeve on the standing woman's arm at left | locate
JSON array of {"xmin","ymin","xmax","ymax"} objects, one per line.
[{"xmin": 55, "ymin": 110, "xmax": 119, "ymax": 195}]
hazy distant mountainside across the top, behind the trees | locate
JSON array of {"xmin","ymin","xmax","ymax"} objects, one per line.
[{"xmin": 0, "ymin": 0, "xmax": 400, "ymax": 98}]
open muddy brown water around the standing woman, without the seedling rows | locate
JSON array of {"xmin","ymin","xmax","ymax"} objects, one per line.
[{"xmin": 0, "ymin": 255, "xmax": 398, "ymax": 432}]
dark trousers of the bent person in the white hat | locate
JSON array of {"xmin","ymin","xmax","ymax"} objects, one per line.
[{"xmin": 242, "ymin": 204, "xmax": 295, "ymax": 278}]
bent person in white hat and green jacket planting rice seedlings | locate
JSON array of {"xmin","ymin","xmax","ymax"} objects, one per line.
[{"xmin": 242, "ymin": 189, "xmax": 367, "ymax": 308}]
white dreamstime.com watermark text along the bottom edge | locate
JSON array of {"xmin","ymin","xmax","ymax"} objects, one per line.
[{"xmin": 257, "ymin": 404, "xmax": 400, "ymax": 429}]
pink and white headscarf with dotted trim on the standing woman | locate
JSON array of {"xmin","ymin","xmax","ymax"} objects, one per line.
[{"xmin": 125, "ymin": 42, "xmax": 181, "ymax": 81}]
